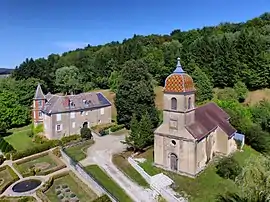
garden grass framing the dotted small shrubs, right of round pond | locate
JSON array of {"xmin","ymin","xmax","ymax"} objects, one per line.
[{"xmin": 45, "ymin": 174, "xmax": 97, "ymax": 202}]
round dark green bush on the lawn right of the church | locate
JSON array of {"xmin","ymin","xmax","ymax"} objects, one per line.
[{"xmin": 216, "ymin": 157, "xmax": 242, "ymax": 180}]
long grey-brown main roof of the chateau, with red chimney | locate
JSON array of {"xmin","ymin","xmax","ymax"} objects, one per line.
[{"xmin": 43, "ymin": 92, "xmax": 111, "ymax": 114}]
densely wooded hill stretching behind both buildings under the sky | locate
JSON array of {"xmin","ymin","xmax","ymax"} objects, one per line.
[{"xmin": 12, "ymin": 13, "xmax": 270, "ymax": 92}]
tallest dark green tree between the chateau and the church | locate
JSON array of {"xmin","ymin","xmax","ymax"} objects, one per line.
[{"xmin": 115, "ymin": 60, "xmax": 159, "ymax": 128}]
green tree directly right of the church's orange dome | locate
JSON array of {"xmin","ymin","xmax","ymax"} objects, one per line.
[{"xmin": 191, "ymin": 63, "xmax": 213, "ymax": 103}]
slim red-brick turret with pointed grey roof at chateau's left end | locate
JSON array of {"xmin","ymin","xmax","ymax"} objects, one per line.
[{"xmin": 32, "ymin": 84, "xmax": 46, "ymax": 126}]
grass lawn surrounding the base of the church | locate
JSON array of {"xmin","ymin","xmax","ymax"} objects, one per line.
[{"xmin": 139, "ymin": 146, "xmax": 258, "ymax": 202}]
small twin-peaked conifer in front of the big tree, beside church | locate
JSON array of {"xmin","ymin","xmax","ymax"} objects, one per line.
[{"xmin": 124, "ymin": 112, "xmax": 154, "ymax": 151}]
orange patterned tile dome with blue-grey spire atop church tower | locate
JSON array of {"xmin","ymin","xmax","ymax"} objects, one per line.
[{"xmin": 164, "ymin": 58, "xmax": 195, "ymax": 93}]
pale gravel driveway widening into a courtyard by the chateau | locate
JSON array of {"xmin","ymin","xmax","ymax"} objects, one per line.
[{"xmin": 80, "ymin": 134, "xmax": 156, "ymax": 202}]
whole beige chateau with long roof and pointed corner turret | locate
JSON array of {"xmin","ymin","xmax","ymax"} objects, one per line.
[{"xmin": 32, "ymin": 84, "xmax": 111, "ymax": 139}]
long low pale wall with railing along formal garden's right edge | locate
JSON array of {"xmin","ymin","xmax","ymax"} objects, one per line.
[{"xmin": 60, "ymin": 149, "xmax": 119, "ymax": 202}]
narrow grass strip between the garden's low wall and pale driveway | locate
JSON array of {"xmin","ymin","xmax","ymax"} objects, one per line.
[{"xmin": 85, "ymin": 165, "xmax": 133, "ymax": 202}]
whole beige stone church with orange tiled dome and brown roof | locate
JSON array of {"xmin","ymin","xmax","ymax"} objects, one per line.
[{"xmin": 154, "ymin": 58, "xmax": 237, "ymax": 177}]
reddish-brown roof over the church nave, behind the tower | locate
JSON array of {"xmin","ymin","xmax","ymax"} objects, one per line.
[{"xmin": 186, "ymin": 102, "xmax": 236, "ymax": 140}]
